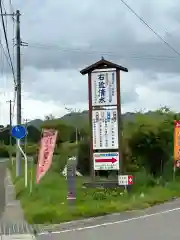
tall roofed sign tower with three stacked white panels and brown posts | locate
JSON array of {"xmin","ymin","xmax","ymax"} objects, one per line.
[{"xmin": 80, "ymin": 58, "xmax": 128, "ymax": 182}]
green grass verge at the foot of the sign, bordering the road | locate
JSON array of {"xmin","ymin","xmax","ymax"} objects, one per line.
[{"xmin": 8, "ymin": 159, "xmax": 180, "ymax": 224}]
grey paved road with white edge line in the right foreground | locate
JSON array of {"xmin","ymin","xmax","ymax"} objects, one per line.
[{"xmin": 37, "ymin": 200, "xmax": 180, "ymax": 240}]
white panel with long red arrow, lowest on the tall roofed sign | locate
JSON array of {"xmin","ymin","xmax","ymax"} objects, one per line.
[{"xmin": 93, "ymin": 152, "xmax": 119, "ymax": 171}]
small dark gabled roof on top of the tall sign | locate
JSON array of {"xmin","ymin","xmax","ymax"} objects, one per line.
[{"xmin": 80, "ymin": 57, "xmax": 128, "ymax": 75}]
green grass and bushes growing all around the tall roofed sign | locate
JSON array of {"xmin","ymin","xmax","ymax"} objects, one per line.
[{"xmin": 5, "ymin": 107, "xmax": 180, "ymax": 223}]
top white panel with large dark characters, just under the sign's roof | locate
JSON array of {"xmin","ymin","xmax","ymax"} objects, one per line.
[{"xmin": 91, "ymin": 71, "xmax": 117, "ymax": 106}]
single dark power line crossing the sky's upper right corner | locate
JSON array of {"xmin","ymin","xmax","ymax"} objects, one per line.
[{"xmin": 120, "ymin": 0, "xmax": 180, "ymax": 56}]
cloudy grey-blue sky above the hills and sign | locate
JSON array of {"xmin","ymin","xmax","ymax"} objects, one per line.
[{"xmin": 0, "ymin": 0, "xmax": 180, "ymax": 124}]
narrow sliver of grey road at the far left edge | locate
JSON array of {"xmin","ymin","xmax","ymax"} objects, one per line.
[{"xmin": 0, "ymin": 161, "xmax": 6, "ymax": 217}]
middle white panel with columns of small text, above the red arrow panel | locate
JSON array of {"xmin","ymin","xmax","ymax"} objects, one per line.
[{"xmin": 92, "ymin": 109, "xmax": 119, "ymax": 150}]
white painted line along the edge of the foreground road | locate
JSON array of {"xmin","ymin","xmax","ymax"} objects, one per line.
[{"xmin": 38, "ymin": 205, "xmax": 180, "ymax": 235}]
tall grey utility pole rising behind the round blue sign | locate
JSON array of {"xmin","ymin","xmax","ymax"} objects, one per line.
[{"xmin": 16, "ymin": 10, "xmax": 22, "ymax": 177}]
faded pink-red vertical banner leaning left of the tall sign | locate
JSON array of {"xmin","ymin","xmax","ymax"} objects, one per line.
[{"xmin": 36, "ymin": 129, "xmax": 58, "ymax": 184}]
